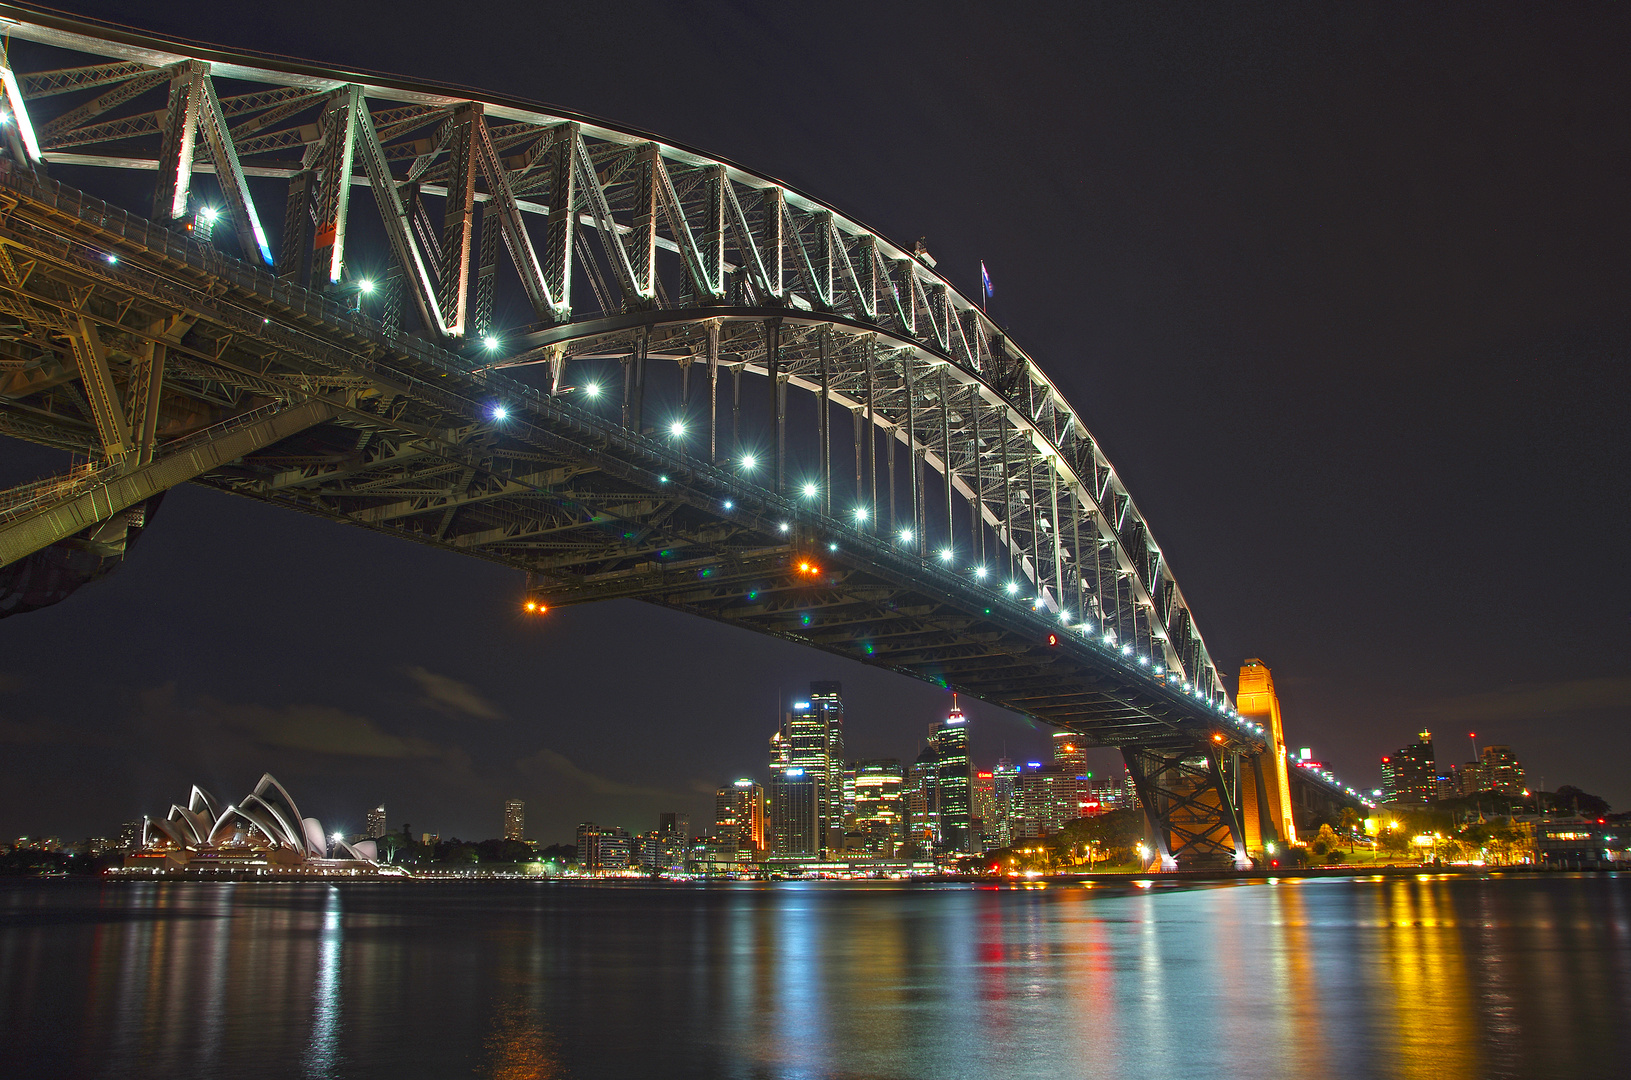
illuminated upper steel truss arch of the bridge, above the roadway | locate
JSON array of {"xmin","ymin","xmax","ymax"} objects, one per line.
[{"xmin": 0, "ymin": 5, "xmax": 1227, "ymax": 702}]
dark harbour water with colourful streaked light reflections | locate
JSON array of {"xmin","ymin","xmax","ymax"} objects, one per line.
[{"xmin": 0, "ymin": 876, "xmax": 1631, "ymax": 1080}]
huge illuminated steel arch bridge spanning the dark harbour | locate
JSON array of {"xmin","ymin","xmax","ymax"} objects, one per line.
[{"xmin": 0, "ymin": 5, "xmax": 1285, "ymax": 866}]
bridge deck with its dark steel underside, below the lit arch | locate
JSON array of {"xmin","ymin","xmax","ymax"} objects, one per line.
[{"xmin": 0, "ymin": 173, "xmax": 1262, "ymax": 855}]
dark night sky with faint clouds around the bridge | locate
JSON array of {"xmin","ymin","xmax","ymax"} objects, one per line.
[{"xmin": 0, "ymin": 0, "xmax": 1631, "ymax": 843}]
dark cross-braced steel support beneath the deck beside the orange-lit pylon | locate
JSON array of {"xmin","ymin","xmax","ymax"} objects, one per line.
[{"xmin": 1122, "ymin": 746, "xmax": 1251, "ymax": 871}]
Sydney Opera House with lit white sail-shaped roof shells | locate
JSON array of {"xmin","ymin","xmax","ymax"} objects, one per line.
[{"xmin": 124, "ymin": 773, "xmax": 394, "ymax": 876}]
